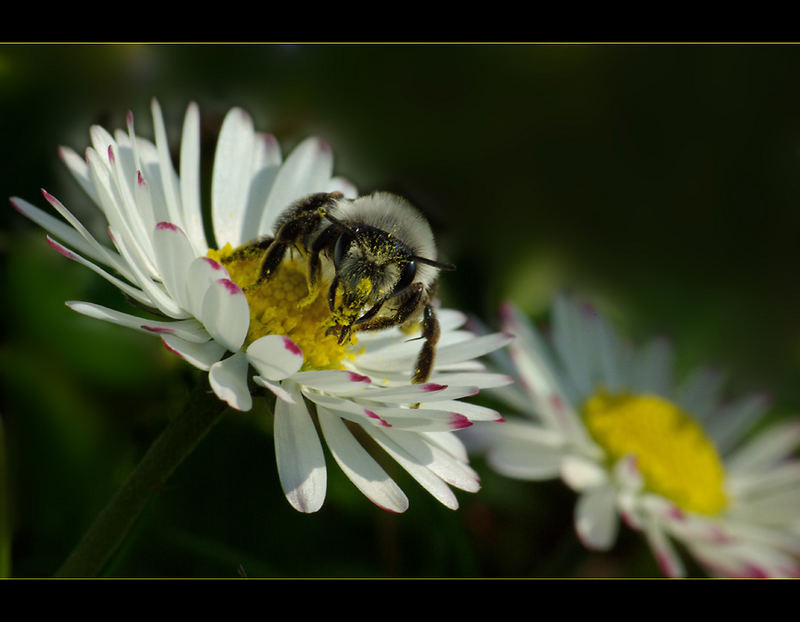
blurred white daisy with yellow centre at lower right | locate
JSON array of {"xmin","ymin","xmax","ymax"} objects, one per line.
[{"xmin": 476, "ymin": 297, "xmax": 800, "ymax": 577}]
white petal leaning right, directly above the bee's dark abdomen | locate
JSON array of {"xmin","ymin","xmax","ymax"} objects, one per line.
[{"xmin": 258, "ymin": 138, "xmax": 333, "ymax": 234}]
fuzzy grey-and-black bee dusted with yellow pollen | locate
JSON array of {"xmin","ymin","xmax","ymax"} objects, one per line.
[{"xmin": 238, "ymin": 192, "xmax": 455, "ymax": 383}]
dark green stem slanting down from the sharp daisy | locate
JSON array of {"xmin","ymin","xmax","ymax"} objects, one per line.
[{"xmin": 56, "ymin": 378, "xmax": 226, "ymax": 577}]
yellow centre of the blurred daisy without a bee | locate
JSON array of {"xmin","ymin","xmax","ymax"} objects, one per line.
[{"xmin": 583, "ymin": 391, "xmax": 727, "ymax": 515}]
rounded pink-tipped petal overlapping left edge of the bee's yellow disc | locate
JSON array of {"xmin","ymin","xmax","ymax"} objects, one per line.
[{"xmin": 200, "ymin": 279, "xmax": 250, "ymax": 352}]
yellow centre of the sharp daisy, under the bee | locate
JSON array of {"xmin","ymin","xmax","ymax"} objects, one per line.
[{"xmin": 208, "ymin": 244, "xmax": 358, "ymax": 370}]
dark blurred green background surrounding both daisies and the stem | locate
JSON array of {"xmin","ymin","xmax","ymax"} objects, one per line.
[{"xmin": 0, "ymin": 44, "xmax": 800, "ymax": 577}]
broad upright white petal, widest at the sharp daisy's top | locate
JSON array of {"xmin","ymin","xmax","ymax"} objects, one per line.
[{"xmin": 211, "ymin": 108, "xmax": 254, "ymax": 248}]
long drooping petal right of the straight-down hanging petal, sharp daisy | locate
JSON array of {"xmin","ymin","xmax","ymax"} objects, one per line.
[{"xmin": 317, "ymin": 408, "xmax": 408, "ymax": 512}]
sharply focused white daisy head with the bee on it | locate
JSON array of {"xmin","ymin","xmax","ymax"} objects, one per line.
[{"xmin": 11, "ymin": 101, "xmax": 511, "ymax": 512}]
